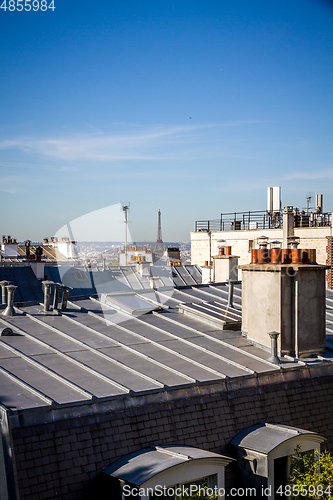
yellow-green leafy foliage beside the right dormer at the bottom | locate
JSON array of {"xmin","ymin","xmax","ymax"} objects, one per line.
[{"xmin": 288, "ymin": 446, "xmax": 333, "ymax": 500}]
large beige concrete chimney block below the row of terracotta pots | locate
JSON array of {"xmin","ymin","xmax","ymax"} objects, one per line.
[{"xmin": 242, "ymin": 264, "xmax": 326, "ymax": 357}]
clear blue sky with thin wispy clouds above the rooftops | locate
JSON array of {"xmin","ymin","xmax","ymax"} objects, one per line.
[{"xmin": 0, "ymin": 0, "xmax": 333, "ymax": 241}]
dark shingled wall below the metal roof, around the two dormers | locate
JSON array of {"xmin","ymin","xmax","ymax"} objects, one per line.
[{"xmin": 12, "ymin": 366, "xmax": 333, "ymax": 500}]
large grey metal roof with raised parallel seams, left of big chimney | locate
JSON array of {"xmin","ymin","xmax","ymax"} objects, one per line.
[{"xmin": 0, "ymin": 266, "xmax": 333, "ymax": 411}]
